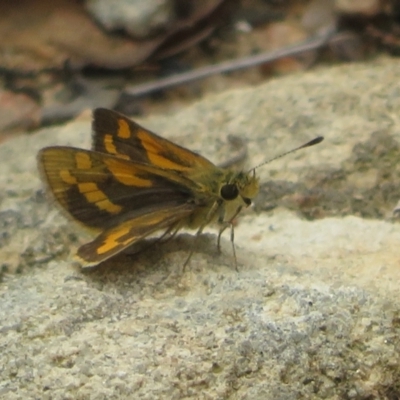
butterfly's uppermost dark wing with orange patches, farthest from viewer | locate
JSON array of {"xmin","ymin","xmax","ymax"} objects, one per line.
[{"xmin": 92, "ymin": 108, "xmax": 216, "ymax": 176}]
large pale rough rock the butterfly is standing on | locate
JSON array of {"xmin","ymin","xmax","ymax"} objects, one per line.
[{"xmin": 0, "ymin": 59, "xmax": 400, "ymax": 399}]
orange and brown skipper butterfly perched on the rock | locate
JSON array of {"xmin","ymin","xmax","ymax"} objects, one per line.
[{"xmin": 38, "ymin": 108, "xmax": 323, "ymax": 266}]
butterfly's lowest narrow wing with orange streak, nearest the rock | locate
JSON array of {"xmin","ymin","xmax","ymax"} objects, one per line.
[{"xmin": 77, "ymin": 204, "xmax": 193, "ymax": 266}]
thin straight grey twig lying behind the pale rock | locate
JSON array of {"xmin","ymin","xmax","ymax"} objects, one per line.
[{"xmin": 123, "ymin": 32, "xmax": 333, "ymax": 97}]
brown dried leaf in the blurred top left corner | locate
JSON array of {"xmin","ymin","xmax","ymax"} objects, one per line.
[{"xmin": 0, "ymin": 0, "xmax": 161, "ymax": 72}]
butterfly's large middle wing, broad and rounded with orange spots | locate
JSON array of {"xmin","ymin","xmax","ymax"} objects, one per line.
[{"xmin": 38, "ymin": 146, "xmax": 196, "ymax": 229}]
